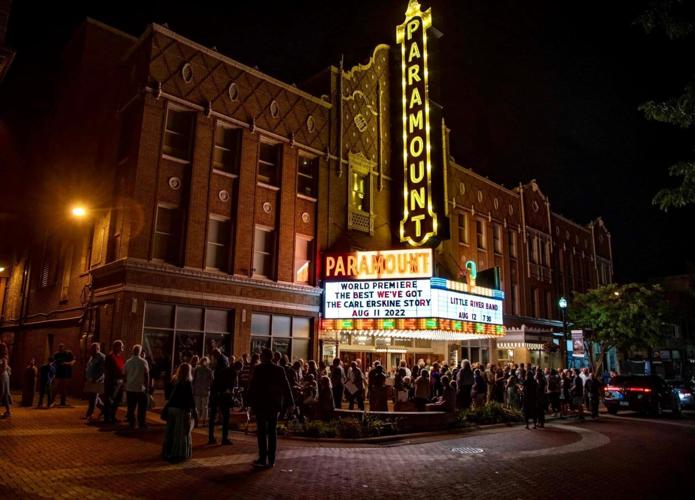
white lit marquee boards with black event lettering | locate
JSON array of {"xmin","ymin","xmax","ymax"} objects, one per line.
[{"xmin": 324, "ymin": 278, "xmax": 503, "ymax": 325}]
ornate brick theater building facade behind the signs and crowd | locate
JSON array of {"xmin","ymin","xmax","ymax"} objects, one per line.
[{"xmin": 0, "ymin": 5, "xmax": 612, "ymax": 389}]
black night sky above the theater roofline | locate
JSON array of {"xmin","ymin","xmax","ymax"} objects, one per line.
[{"xmin": 3, "ymin": 0, "xmax": 695, "ymax": 281}]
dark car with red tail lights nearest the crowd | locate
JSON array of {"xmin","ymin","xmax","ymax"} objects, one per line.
[{"xmin": 603, "ymin": 375, "xmax": 681, "ymax": 415}]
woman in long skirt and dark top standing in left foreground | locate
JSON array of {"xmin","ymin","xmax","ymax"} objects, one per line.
[{"xmin": 161, "ymin": 363, "xmax": 198, "ymax": 462}]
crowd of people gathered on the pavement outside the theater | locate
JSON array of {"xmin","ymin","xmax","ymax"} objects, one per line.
[{"xmin": 0, "ymin": 340, "xmax": 612, "ymax": 467}]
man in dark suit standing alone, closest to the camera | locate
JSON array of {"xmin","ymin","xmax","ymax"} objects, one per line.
[{"xmin": 248, "ymin": 348, "xmax": 294, "ymax": 467}]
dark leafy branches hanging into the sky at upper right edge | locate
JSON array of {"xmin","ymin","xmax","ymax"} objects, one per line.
[{"xmin": 636, "ymin": 0, "xmax": 695, "ymax": 211}]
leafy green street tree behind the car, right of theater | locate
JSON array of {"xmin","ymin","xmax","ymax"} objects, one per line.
[{"xmin": 569, "ymin": 283, "xmax": 666, "ymax": 376}]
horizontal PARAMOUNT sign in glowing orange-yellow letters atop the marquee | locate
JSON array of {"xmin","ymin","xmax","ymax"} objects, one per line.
[{"xmin": 324, "ymin": 248, "xmax": 432, "ymax": 280}]
